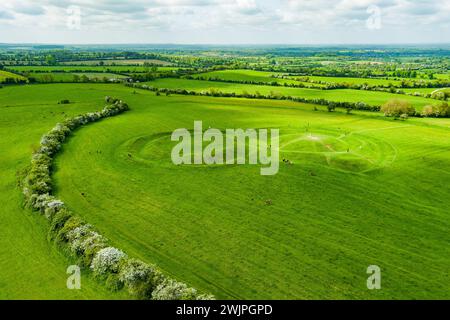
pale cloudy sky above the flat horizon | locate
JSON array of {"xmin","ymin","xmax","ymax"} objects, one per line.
[{"xmin": 0, "ymin": 0, "xmax": 450, "ymax": 44}]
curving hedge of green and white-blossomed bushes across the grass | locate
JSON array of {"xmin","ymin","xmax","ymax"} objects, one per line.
[{"xmin": 21, "ymin": 97, "xmax": 214, "ymax": 300}]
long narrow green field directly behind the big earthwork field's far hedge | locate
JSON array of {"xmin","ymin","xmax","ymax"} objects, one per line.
[{"xmin": 147, "ymin": 79, "xmax": 435, "ymax": 110}]
